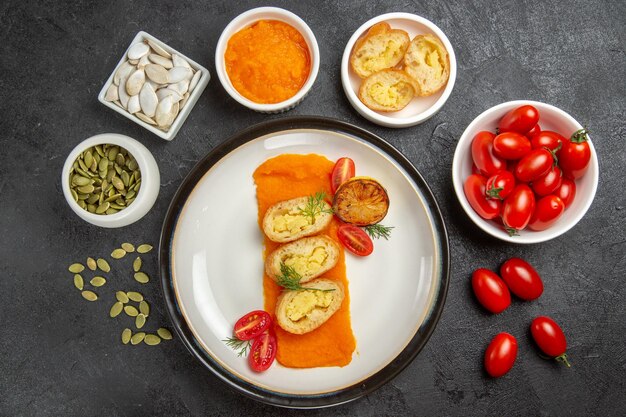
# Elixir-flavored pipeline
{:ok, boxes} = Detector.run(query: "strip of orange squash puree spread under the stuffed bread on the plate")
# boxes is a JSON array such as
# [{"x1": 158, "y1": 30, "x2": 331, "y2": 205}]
[{"x1": 254, "y1": 154, "x2": 356, "y2": 368}]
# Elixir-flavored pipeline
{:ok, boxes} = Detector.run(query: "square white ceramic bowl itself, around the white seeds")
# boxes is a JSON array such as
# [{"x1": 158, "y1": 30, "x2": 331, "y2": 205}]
[{"x1": 98, "y1": 31, "x2": 211, "y2": 140}]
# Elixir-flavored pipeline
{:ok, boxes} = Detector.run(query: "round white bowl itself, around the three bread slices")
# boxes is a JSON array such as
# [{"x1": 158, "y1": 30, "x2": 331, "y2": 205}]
[{"x1": 341, "y1": 13, "x2": 456, "y2": 128}]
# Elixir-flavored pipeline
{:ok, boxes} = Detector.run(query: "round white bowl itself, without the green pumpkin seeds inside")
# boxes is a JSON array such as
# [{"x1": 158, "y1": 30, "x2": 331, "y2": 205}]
[{"x1": 61, "y1": 133, "x2": 161, "y2": 228}]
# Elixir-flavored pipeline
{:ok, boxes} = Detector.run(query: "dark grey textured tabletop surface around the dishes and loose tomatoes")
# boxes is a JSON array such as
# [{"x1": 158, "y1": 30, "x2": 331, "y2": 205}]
[{"x1": 0, "y1": 0, "x2": 626, "y2": 416}]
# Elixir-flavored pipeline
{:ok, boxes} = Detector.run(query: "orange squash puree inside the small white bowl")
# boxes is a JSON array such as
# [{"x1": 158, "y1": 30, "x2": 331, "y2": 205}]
[{"x1": 224, "y1": 20, "x2": 311, "y2": 104}]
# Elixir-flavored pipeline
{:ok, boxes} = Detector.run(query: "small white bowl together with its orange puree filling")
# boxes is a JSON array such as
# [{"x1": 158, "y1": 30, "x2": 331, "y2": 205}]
[{"x1": 215, "y1": 7, "x2": 320, "y2": 113}]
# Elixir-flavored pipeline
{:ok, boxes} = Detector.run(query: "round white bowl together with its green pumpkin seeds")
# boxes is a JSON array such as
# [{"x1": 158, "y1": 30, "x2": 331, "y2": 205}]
[{"x1": 61, "y1": 133, "x2": 160, "y2": 228}]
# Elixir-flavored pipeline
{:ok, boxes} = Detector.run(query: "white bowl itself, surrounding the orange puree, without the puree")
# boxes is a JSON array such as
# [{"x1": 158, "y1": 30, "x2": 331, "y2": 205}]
[{"x1": 215, "y1": 7, "x2": 320, "y2": 113}]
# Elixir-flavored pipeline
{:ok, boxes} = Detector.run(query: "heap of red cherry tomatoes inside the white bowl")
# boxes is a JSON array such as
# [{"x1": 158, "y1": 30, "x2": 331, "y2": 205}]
[{"x1": 464, "y1": 105, "x2": 591, "y2": 236}]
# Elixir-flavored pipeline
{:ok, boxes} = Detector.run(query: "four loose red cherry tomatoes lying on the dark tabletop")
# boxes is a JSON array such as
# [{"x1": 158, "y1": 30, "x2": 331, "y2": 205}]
[{"x1": 472, "y1": 258, "x2": 570, "y2": 378}]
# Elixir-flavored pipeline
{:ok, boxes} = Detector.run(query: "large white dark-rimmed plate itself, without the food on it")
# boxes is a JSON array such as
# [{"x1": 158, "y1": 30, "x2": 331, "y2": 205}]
[{"x1": 160, "y1": 118, "x2": 449, "y2": 407}]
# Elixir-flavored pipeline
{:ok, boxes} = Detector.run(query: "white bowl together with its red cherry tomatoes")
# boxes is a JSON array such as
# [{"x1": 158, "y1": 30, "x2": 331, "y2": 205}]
[{"x1": 452, "y1": 100, "x2": 599, "y2": 243}]
